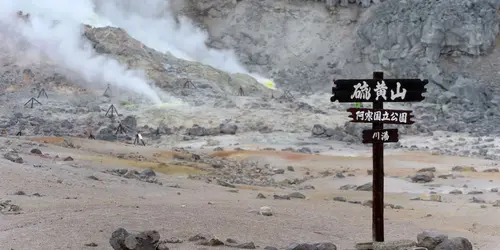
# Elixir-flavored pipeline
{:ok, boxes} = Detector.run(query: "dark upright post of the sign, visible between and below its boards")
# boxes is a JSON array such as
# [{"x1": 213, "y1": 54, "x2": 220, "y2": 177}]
[{"x1": 372, "y1": 72, "x2": 384, "y2": 242}]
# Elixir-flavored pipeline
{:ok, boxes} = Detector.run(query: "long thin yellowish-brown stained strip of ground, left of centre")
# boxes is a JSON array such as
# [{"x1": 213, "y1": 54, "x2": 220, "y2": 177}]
[{"x1": 81, "y1": 156, "x2": 207, "y2": 175}]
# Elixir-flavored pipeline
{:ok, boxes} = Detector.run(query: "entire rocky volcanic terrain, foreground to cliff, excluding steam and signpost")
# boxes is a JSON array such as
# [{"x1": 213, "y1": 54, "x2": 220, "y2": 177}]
[{"x1": 0, "y1": 0, "x2": 500, "y2": 250}]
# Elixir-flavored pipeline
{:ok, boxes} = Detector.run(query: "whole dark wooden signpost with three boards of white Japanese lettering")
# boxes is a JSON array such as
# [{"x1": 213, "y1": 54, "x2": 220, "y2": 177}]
[{"x1": 330, "y1": 72, "x2": 429, "y2": 242}]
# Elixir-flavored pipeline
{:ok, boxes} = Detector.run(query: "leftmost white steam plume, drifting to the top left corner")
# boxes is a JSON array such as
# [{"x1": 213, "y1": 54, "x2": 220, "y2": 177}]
[{"x1": 0, "y1": 0, "x2": 161, "y2": 103}]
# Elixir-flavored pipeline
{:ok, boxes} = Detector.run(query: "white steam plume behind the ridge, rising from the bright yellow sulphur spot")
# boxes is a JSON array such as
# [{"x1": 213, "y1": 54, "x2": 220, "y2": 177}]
[{"x1": 94, "y1": 0, "x2": 276, "y2": 88}]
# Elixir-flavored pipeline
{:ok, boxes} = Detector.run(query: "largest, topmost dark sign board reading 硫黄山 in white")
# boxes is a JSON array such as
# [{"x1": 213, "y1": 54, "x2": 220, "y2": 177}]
[{"x1": 330, "y1": 79, "x2": 429, "y2": 102}]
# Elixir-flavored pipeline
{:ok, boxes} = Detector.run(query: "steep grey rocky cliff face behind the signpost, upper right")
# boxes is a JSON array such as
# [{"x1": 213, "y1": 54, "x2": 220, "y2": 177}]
[{"x1": 173, "y1": 0, "x2": 500, "y2": 134}]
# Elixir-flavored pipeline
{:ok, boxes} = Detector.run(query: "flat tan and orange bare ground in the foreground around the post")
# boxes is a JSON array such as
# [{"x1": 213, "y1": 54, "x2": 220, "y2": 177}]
[{"x1": 0, "y1": 137, "x2": 500, "y2": 250}]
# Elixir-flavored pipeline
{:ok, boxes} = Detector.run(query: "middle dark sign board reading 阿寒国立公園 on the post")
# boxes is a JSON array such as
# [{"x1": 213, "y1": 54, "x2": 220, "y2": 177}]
[{"x1": 347, "y1": 108, "x2": 415, "y2": 124}]
